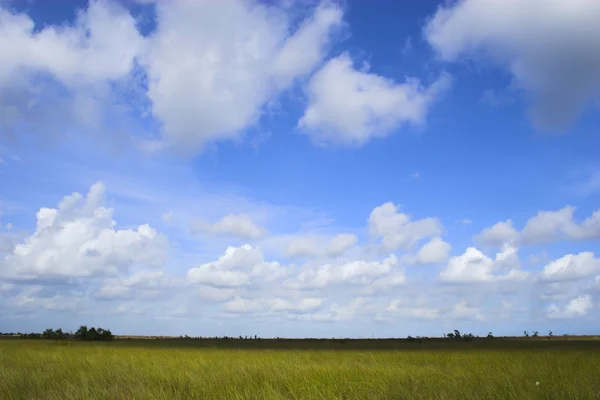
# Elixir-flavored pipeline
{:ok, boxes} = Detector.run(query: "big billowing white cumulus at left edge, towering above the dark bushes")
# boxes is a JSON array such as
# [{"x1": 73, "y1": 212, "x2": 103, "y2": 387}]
[{"x1": 1, "y1": 183, "x2": 168, "y2": 280}]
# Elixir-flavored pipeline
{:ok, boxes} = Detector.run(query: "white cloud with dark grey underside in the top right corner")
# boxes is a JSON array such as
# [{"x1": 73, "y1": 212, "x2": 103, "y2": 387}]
[{"x1": 425, "y1": 0, "x2": 600, "y2": 130}]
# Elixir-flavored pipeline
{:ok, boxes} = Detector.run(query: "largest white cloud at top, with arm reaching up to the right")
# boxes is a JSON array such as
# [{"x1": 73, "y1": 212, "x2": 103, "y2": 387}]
[{"x1": 142, "y1": 0, "x2": 342, "y2": 149}]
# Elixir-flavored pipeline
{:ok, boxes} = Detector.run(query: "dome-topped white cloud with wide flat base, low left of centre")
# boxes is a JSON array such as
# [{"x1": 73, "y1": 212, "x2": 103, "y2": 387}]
[{"x1": 187, "y1": 244, "x2": 291, "y2": 288}]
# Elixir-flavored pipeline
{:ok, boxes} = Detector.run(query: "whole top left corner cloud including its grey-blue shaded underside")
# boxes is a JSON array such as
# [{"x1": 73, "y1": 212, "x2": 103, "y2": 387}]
[{"x1": 0, "y1": 1, "x2": 145, "y2": 133}]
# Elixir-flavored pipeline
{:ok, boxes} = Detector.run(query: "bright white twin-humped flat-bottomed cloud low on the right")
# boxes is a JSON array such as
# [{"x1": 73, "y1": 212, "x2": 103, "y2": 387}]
[{"x1": 439, "y1": 246, "x2": 528, "y2": 282}]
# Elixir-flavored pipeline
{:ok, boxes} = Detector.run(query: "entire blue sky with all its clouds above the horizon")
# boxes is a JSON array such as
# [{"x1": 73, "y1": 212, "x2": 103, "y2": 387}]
[{"x1": 0, "y1": 0, "x2": 600, "y2": 338}]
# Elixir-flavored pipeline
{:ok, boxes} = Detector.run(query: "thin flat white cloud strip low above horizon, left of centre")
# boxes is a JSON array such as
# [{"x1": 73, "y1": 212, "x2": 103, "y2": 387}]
[{"x1": 223, "y1": 296, "x2": 325, "y2": 314}]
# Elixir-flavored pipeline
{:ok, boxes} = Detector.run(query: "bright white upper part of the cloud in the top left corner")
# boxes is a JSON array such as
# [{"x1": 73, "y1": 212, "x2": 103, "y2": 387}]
[{"x1": 0, "y1": 1, "x2": 144, "y2": 86}]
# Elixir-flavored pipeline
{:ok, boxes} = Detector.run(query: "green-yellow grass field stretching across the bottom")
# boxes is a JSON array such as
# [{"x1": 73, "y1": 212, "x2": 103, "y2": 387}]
[{"x1": 0, "y1": 339, "x2": 600, "y2": 400}]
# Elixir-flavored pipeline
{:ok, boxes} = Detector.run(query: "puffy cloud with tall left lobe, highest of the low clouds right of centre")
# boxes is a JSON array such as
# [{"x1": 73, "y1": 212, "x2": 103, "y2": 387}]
[{"x1": 369, "y1": 202, "x2": 442, "y2": 251}]
